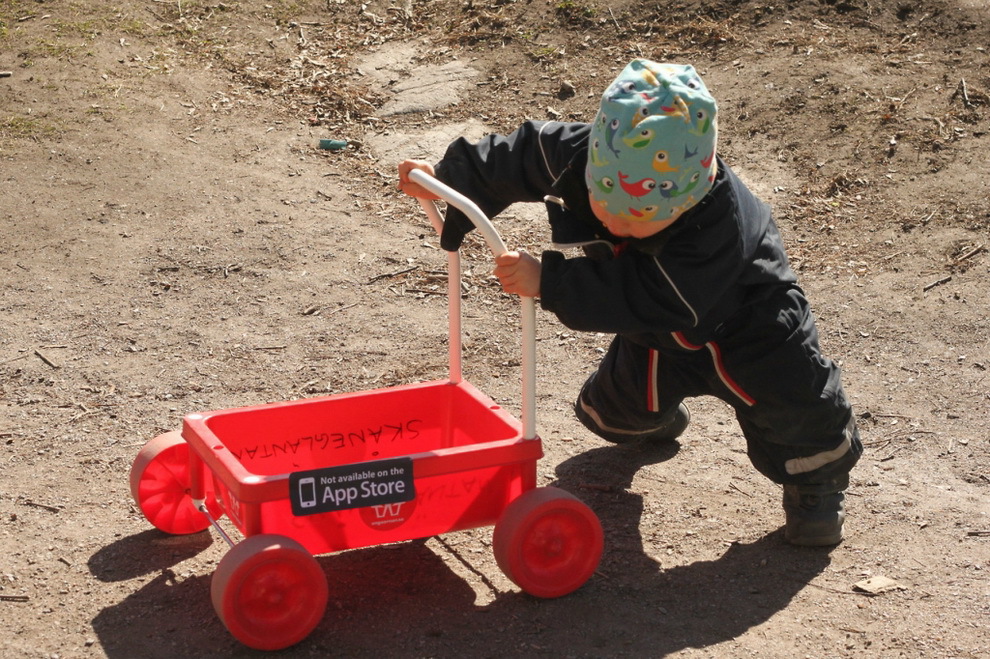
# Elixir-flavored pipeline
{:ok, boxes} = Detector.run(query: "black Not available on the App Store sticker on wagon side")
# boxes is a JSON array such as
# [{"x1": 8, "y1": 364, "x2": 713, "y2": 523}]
[{"x1": 289, "y1": 458, "x2": 416, "y2": 517}]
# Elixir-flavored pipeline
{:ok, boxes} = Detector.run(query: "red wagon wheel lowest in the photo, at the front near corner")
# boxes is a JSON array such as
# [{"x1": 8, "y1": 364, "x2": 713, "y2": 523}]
[{"x1": 210, "y1": 535, "x2": 328, "y2": 650}]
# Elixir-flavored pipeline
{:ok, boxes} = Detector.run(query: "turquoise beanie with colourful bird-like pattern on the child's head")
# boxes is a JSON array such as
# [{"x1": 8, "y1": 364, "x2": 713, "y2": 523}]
[{"x1": 585, "y1": 59, "x2": 718, "y2": 222}]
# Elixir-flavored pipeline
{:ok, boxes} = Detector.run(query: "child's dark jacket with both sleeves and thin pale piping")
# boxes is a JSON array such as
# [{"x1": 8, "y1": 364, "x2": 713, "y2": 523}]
[{"x1": 436, "y1": 122, "x2": 796, "y2": 349}]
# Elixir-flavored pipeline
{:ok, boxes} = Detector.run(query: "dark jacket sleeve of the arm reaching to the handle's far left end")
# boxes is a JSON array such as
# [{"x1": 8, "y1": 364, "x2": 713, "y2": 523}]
[{"x1": 436, "y1": 121, "x2": 588, "y2": 222}]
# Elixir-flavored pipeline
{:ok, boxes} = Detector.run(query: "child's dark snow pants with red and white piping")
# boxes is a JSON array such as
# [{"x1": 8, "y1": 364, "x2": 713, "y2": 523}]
[{"x1": 581, "y1": 287, "x2": 863, "y2": 489}]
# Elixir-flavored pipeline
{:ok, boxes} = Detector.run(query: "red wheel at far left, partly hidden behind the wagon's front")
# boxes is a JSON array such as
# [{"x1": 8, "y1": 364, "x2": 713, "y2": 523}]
[{"x1": 130, "y1": 431, "x2": 221, "y2": 535}]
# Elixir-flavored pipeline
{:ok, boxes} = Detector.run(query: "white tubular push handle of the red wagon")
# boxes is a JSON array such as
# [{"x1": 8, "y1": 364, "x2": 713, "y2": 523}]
[{"x1": 409, "y1": 169, "x2": 536, "y2": 439}]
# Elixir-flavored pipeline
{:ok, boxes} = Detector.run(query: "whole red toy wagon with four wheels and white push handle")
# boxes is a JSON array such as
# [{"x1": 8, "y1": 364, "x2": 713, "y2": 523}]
[{"x1": 130, "y1": 172, "x2": 603, "y2": 650}]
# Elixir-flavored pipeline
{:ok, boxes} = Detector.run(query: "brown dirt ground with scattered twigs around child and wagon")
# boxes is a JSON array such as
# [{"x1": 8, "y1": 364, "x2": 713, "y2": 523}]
[{"x1": 0, "y1": 0, "x2": 990, "y2": 659}]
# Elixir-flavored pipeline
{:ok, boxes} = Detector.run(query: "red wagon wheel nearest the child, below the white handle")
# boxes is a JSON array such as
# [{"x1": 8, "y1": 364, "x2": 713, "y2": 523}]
[{"x1": 492, "y1": 487, "x2": 605, "y2": 598}]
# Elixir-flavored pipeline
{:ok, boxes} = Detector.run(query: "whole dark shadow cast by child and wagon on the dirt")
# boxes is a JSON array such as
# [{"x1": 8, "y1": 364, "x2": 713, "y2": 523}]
[{"x1": 90, "y1": 444, "x2": 830, "y2": 659}]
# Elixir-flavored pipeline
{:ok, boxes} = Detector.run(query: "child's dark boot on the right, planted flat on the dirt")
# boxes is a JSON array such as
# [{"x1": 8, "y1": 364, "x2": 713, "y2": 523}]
[{"x1": 784, "y1": 485, "x2": 846, "y2": 547}]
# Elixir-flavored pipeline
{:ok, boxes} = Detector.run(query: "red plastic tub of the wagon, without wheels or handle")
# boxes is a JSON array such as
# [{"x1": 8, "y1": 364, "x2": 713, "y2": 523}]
[{"x1": 182, "y1": 380, "x2": 543, "y2": 554}]
